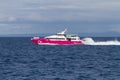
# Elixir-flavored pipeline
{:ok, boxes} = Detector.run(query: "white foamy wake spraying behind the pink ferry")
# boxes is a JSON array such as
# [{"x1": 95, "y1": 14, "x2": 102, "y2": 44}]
[{"x1": 82, "y1": 38, "x2": 120, "y2": 45}]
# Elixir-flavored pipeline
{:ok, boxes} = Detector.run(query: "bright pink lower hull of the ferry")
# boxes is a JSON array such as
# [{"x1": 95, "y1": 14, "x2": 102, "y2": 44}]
[{"x1": 31, "y1": 38, "x2": 83, "y2": 45}]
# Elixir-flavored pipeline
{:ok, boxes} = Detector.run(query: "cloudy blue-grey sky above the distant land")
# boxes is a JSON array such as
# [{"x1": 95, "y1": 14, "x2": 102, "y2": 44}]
[{"x1": 0, "y1": 0, "x2": 120, "y2": 35}]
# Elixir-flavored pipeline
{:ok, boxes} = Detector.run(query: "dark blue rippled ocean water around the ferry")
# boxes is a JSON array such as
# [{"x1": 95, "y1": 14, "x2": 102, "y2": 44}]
[{"x1": 0, "y1": 37, "x2": 120, "y2": 80}]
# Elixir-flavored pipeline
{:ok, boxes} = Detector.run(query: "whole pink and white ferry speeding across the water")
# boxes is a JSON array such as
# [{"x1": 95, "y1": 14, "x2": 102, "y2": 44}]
[{"x1": 31, "y1": 29, "x2": 83, "y2": 45}]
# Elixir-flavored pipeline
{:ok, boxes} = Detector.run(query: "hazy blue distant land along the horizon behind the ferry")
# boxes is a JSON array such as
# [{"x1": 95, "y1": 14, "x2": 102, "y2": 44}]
[{"x1": 0, "y1": 32, "x2": 120, "y2": 37}]
